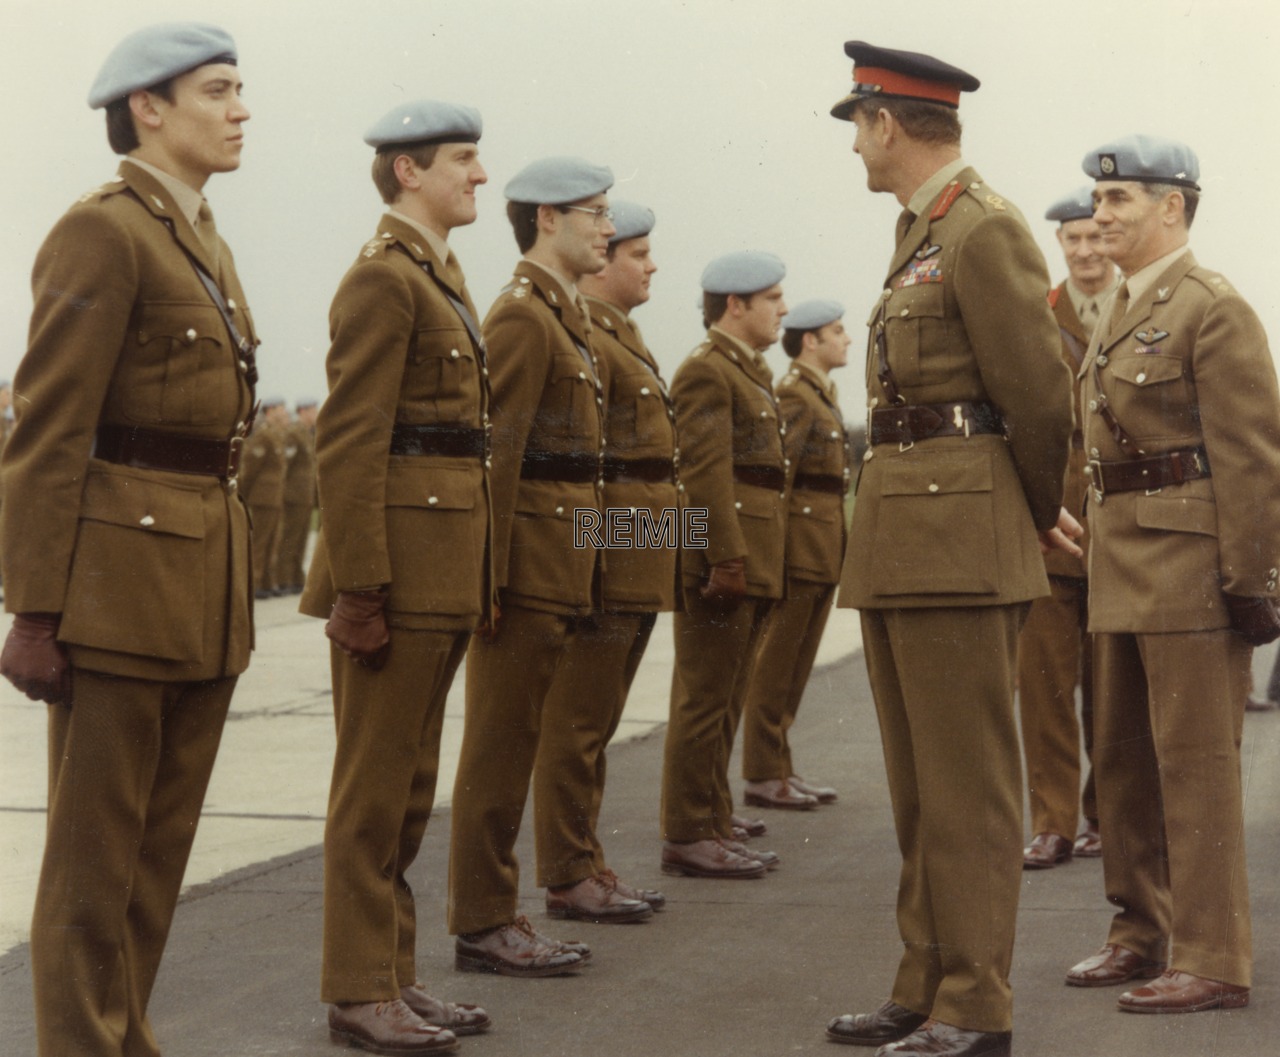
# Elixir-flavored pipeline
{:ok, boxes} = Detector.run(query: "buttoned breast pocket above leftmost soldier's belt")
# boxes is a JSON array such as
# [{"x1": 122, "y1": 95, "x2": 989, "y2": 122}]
[{"x1": 126, "y1": 302, "x2": 239, "y2": 426}]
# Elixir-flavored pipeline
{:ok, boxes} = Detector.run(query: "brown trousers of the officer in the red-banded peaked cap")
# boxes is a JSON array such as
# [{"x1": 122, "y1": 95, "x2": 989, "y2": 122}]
[{"x1": 861, "y1": 604, "x2": 1027, "y2": 1031}]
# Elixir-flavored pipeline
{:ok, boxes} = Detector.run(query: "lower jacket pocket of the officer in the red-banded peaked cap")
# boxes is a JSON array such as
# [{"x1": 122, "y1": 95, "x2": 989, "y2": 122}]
[{"x1": 872, "y1": 452, "x2": 998, "y2": 595}]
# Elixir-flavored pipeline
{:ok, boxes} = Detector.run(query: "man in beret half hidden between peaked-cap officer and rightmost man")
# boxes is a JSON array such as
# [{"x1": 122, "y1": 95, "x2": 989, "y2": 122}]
[{"x1": 1018, "y1": 187, "x2": 1116, "y2": 870}]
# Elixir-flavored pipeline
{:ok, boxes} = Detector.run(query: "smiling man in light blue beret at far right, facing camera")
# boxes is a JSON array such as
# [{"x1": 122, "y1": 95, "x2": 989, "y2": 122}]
[{"x1": 1066, "y1": 136, "x2": 1280, "y2": 1013}]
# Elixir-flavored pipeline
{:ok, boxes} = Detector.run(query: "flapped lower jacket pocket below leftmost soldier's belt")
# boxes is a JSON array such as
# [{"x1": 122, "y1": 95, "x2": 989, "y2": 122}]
[{"x1": 59, "y1": 471, "x2": 205, "y2": 663}]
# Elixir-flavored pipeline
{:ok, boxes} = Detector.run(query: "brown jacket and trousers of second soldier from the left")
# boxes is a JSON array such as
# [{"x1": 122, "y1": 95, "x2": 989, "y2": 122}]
[{"x1": 301, "y1": 215, "x2": 493, "y2": 1002}]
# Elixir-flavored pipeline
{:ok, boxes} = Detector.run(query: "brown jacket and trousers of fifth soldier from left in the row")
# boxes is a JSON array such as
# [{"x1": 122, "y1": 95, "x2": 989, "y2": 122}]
[{"x1": 662, "y1": 328, "x2": 786, "y2": 843}]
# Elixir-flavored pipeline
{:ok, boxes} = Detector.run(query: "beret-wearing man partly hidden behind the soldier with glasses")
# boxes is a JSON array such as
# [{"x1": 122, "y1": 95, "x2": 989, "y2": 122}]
[{"x1": 534, "y1": 202, "x2": 678, "y2": 923}]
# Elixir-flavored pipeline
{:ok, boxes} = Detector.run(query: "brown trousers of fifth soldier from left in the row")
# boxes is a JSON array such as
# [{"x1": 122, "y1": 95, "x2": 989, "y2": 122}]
[{"x1": 662, "y1": 586, "x2": 773, "y2": 843}]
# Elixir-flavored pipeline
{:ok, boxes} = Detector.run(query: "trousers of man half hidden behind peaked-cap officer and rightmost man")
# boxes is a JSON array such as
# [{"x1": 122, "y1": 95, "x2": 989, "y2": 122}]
[{"x1": 1018, "y1": 576, "x2": 1098, "y2": 841}]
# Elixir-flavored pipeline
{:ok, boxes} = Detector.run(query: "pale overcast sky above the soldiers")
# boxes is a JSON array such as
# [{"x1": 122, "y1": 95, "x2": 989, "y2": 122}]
[{"x1": 0, "y1": 0, "x2": 1280, "y2": 421}]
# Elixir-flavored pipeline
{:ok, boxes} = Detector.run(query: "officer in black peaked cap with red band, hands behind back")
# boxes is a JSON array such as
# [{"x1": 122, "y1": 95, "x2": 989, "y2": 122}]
[{"x1": 827, "y1": 41, "x2": 1079, "y2": 1057}]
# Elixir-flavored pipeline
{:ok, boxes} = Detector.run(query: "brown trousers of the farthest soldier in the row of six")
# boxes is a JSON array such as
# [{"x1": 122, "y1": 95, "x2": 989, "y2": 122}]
[{"x1": 742, "y1": 580, "x2": 836, "y2": 782}]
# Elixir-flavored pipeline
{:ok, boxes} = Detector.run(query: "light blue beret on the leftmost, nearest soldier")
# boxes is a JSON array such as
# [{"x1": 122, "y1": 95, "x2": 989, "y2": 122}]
[{"x1": 88, "y1": 22, "x2": 236, "y2": 110}]
